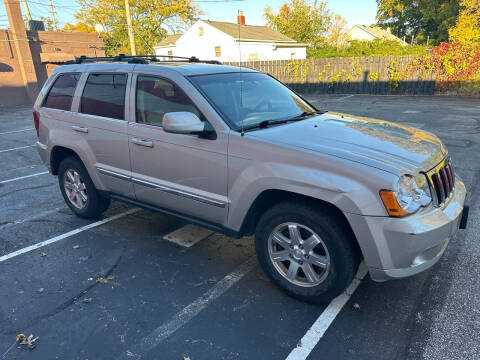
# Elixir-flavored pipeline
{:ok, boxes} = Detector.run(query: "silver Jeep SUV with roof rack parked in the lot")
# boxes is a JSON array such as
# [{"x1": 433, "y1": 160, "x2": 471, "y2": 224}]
[{"x1": 34, "y1": 57, "x2": 468, "y2": 302}]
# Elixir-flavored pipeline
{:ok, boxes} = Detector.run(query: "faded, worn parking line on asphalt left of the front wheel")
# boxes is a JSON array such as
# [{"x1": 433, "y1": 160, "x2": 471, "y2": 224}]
[{"x1": 123, "y1": 258, "x2": 257, "y2": 358}]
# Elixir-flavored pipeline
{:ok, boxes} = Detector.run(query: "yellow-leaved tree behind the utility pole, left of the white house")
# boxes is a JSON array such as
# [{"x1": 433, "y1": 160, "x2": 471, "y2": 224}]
[{"x1": 75, "y1": 0, "x2": 200, "y2": 55}]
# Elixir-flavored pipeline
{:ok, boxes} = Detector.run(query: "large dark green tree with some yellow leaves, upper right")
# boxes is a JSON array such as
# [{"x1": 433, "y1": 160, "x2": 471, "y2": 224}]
[{"x1": 377, "y1": 0, "x2": 460, "y2": 44}]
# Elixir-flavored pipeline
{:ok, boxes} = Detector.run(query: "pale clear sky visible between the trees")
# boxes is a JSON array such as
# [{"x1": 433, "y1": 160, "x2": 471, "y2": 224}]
[{"x1": 0, "y1": 0, "x2": 377, "y2": 28}]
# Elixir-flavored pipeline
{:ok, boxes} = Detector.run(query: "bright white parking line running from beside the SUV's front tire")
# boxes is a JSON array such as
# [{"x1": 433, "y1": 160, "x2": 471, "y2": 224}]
[{"x1": 286, "y1": 262, "x2": 367, "y2": 360}]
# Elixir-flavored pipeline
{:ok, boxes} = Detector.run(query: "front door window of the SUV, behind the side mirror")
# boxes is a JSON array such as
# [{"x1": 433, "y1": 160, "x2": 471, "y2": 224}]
[{"x1": 136, "y1": 75, "x2": 204, "y2": 126}]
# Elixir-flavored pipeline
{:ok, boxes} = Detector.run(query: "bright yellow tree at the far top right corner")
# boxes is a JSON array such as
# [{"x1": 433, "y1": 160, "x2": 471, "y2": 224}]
[{"x1": 450, "y1": 0, "x2": 480, "y2": 45}]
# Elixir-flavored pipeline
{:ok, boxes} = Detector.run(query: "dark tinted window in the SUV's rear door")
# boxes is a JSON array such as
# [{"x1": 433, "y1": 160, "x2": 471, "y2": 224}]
[{"x1": 80, "y1": 74, "x2": 127, "y2": 120}]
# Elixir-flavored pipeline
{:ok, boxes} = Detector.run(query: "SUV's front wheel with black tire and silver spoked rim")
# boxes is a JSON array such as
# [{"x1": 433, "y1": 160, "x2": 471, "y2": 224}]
[{"x1": 255, "y1": 200, "x2": 360, "y2": 303}]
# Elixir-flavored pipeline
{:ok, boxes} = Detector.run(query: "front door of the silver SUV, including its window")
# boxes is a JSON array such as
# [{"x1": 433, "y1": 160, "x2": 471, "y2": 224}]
[{"x1": 128, "y1": 74, "x2": 228, "y2": 224}]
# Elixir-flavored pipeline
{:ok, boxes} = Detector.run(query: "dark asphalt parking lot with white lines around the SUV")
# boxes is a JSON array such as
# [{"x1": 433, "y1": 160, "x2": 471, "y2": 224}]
[{"x1": 0, "y1": 95, "x2": 480, "y2": 360}]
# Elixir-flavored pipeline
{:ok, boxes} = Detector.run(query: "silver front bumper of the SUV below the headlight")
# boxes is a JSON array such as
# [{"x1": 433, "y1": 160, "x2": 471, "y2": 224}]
[{"x1": 346, "y1": 177, "x2": 468, "y2": 281}]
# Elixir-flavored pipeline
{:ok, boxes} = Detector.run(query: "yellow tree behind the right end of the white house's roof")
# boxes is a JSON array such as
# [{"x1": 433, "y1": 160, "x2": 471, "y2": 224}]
[{"x1": 264, "y1": 0, "x2": 331, "y2": 46}]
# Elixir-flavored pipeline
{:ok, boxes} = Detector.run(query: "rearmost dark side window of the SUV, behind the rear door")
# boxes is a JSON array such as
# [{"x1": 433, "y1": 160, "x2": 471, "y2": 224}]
[{"x1": 43, "y1": 73, "x2": 80, "y2": 111}]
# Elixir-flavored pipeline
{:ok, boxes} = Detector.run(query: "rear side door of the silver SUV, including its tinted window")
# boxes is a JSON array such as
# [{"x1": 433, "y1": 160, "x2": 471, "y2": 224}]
[{"x1": 66, "y1": 66, "x2": 134, "y2": 197}]
